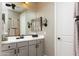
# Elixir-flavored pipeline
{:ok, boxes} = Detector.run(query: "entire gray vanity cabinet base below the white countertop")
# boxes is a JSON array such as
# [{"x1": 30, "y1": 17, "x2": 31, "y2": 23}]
[{"x1": 1, "y1": 39, "x2": 44, "y2": 56}]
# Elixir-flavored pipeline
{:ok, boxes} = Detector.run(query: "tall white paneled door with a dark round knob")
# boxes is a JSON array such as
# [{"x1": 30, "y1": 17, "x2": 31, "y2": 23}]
[{"x1": 55, "y1": 2, "x2": 74, "y2": 56}]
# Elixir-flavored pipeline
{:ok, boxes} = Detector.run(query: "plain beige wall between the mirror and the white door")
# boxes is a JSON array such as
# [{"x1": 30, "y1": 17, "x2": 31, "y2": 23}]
[{"x1": 37, "y1": 2, "x2": 54, "y2": 56}]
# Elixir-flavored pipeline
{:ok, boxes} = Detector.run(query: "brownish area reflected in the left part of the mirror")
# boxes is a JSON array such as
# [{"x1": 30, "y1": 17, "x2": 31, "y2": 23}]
[{"x1": 8, "y1": 10, "x2": 20, "y2": 36}]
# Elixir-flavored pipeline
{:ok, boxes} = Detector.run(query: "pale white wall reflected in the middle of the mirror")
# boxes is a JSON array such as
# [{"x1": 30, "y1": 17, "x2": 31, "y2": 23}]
[{"x1": 20, "y1": 10, "x2": 36, "y2": 35}]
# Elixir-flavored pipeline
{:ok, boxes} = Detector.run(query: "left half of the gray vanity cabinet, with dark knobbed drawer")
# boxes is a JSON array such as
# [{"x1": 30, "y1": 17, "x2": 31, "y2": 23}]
[{"x1": 2, "y1": 41, "x2": 28, "y2": 56}]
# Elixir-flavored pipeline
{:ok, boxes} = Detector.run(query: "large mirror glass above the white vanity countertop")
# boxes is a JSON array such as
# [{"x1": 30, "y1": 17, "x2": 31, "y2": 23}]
[{"x1": 2, "y1": 2, "x2": 41, "y2": 36}]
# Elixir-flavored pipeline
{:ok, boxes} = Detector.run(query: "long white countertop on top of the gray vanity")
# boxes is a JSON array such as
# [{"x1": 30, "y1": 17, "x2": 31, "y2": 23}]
[{"x1": 1, "y1": 35, "x2": 44, "y2": 44}]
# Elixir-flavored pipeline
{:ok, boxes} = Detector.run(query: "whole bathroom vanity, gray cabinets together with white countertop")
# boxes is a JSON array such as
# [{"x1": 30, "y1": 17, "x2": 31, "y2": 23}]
[{"x1": 1, "y1": 35, "x2": 44, "y2": 56}]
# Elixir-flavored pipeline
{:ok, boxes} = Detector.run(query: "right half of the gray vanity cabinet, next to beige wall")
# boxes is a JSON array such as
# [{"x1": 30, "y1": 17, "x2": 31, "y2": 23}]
[{"x1": 29, "y1": 39, "x2": 44, "y2": 56}]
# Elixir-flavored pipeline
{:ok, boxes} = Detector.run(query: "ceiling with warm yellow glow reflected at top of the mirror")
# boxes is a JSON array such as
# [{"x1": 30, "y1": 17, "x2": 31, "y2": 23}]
[{"x1": 3, "y1": 2, "x2": 36, "y2": 13}]
